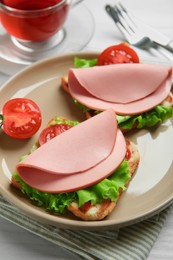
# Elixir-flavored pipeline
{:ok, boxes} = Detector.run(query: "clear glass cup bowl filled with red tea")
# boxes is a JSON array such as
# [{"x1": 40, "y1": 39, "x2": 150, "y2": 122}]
[{"x1": 0, "y1": 0, "x2": 70, "y2": 42}]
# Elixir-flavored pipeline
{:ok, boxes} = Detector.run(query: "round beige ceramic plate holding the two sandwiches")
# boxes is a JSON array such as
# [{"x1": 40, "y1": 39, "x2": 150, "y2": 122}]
[{"x1": 0, "y1": 53, "x2": 173, "y2": 230}]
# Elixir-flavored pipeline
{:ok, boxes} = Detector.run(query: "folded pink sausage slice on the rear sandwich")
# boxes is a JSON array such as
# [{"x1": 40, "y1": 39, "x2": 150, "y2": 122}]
[{"x1": 68, "y1": 64, "x2": 172, "y2": 115}]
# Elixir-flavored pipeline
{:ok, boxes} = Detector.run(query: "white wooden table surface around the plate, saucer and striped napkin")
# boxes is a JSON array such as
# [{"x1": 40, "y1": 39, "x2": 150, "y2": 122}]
[{"x1": 0, "y1": 0, "x2": 173, "y2": 260}]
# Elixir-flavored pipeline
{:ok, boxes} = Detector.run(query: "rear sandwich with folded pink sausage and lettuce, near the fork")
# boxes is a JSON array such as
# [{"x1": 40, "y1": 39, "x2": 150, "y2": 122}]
[{"x1": 61, "y1": 58, "x2": 173, "y2": 132}]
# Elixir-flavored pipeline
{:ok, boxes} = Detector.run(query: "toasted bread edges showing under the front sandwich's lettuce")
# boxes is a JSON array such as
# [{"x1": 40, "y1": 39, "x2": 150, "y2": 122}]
[{"x1": 68, "y1": 140, "x2": 140, "y2": 221}]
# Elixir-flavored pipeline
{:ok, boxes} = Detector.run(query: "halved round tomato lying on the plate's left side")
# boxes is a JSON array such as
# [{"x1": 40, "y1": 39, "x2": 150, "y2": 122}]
[{"x1": 2, "y1": 98, "x2": 42, "y2": 139}]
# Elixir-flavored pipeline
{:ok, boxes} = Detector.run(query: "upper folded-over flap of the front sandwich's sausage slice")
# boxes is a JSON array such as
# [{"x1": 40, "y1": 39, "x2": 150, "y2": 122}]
[{"x1": 17, "y1": 110, "x2": 117, "y2": 174}]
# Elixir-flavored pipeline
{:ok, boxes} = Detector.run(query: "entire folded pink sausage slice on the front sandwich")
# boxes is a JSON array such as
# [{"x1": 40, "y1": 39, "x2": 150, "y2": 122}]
[{"x1": 17, "y1": 110, "x2": 126, "y2": 192}]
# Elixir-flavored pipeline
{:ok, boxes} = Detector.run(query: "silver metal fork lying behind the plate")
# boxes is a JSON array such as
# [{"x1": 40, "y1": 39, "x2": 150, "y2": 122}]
[{"x1": 105, "y1": 3, "x2": 173, "y2": 60}]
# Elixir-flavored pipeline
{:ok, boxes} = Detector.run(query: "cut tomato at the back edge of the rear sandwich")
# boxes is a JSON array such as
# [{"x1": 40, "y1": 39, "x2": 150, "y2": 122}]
[{"x1": 97, "y1": 43, "x2": 139, "y2": 66}]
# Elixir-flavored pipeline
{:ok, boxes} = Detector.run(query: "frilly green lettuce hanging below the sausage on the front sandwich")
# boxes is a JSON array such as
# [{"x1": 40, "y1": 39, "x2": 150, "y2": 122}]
[{"x1": 13, "y1": 160, "x2": 131, "y2": 214}]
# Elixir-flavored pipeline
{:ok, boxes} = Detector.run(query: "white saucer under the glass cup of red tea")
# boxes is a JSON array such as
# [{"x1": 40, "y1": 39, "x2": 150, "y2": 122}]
[{"x1": 0, "y1": 4, "x2": 94, "y2": 65}]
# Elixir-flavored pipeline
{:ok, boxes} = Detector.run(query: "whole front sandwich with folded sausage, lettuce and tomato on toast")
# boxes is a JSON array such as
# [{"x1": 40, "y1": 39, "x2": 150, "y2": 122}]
[{"x1": 11, "y1": 109, "x2": 140, "y2": 221}]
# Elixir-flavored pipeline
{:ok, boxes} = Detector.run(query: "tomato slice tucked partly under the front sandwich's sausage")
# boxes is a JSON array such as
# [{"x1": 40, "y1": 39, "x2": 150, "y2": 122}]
[{"x1": 38, "y1": 124, "x2": 72, "y2": 145}]
